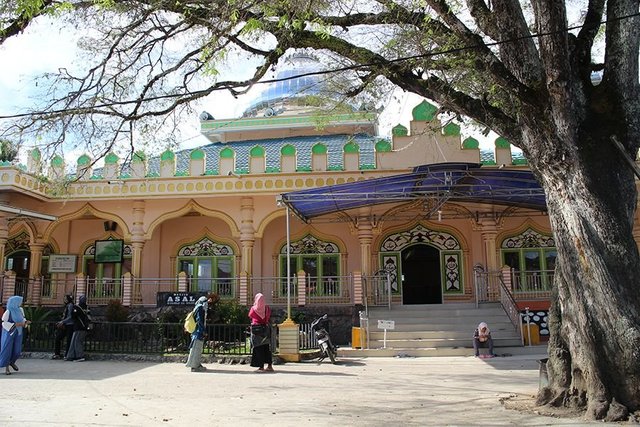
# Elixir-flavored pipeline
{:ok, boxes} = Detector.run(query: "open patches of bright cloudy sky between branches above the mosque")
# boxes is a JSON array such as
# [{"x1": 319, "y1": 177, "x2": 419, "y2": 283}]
[{"x1": 0, "y1": 17, "x2": 496, "y2": 164}]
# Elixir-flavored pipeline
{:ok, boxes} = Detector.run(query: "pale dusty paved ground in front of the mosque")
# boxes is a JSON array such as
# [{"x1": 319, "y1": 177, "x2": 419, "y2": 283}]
[{"x1": 0, "y1": 356, "x2": 602, "y2": 427}]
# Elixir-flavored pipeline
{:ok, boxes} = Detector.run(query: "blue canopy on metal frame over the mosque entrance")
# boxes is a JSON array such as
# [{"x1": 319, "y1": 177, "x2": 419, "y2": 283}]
[{"x1": 281, "y1": 163, "x2": 547, "y2": 222}]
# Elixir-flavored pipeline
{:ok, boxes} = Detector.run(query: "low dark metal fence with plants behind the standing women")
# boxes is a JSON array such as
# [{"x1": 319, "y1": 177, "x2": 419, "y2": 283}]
[{"x1": 23, "y1": 322, "x2": 258, "y2": 356}]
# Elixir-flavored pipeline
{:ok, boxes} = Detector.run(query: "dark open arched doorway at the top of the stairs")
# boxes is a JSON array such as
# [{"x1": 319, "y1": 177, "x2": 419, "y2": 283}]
[{"x1": 401, "y1": 244, "x2": 442, "y2": 304}]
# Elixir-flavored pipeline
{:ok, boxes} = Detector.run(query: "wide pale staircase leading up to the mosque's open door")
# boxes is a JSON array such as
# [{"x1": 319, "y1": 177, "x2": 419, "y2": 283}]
[{"x1": 338, "y1": 303, "x2": 546, "y2": 357}]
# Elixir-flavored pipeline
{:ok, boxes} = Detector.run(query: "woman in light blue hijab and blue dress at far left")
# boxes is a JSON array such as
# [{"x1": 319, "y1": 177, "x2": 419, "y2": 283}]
[{"x1": 0, "y1": 295, "x2": 30, "y2": 375}]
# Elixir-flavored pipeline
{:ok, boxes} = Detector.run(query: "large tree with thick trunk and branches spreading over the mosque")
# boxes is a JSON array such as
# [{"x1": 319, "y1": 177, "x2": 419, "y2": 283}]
[{"x1": 0, "y1": 0, "x2": 640, "y2": 420}]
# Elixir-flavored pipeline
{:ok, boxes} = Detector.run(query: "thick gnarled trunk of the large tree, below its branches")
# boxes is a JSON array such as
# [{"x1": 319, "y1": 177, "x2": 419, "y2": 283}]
[{"x1": 532, "y1": 131, "x2": 640, "y2": 421}]
